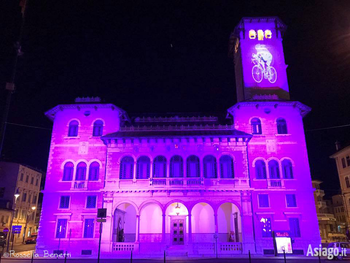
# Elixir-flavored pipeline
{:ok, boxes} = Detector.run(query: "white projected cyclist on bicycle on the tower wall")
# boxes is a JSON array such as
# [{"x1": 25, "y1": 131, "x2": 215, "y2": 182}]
[{"x1": 252, "y1": 44, "x2": 277, "y2": 83}]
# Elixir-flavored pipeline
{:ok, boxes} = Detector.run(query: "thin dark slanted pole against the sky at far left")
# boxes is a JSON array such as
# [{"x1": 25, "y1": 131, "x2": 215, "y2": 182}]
[{"x1": 0, "y1": 0, "x2": 28, "y2": 159}]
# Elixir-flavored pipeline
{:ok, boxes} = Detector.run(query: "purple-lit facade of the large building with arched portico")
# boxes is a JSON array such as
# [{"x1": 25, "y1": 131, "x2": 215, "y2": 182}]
[{"x1": 37, "y1": 18, "x2": 320, "y2": 257}]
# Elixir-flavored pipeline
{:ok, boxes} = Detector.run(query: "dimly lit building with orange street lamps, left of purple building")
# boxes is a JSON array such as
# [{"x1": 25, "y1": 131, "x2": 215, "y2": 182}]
[{"x1": 0, "y1": 162, "x2": 42, "y2": 243}]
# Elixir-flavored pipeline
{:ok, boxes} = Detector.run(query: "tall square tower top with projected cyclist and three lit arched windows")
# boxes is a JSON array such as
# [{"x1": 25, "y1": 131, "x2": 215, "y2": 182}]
[{"x1": 230, "y1": 17, "x2": 289, "y2": 102}]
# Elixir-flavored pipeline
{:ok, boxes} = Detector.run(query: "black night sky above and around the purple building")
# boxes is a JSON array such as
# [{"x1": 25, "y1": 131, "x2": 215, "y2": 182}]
[{"x1": 0, "y1": 0, "x2": 350, "y2": 198}]
